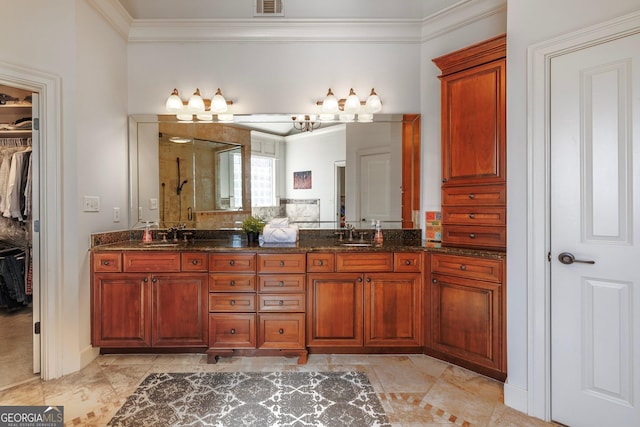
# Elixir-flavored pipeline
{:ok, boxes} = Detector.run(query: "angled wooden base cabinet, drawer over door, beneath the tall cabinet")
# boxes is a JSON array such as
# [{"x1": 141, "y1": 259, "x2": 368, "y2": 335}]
[{"x1": 425, "y1": 254, "x2": 507, "y2": 381}]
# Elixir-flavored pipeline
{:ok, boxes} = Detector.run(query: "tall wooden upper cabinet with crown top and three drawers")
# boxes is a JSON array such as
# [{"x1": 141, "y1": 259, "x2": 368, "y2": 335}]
[{"x1": 433, "y1": 35, "x2": 506, "y2": 249}]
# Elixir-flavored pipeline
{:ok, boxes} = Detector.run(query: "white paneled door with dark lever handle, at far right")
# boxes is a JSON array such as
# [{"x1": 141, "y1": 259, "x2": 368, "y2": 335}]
[{"x1": 550, "y1": 34, "x2": 640, "y2": 427}]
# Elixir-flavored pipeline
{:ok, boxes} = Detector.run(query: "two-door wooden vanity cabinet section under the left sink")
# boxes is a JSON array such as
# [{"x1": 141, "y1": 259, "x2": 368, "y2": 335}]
[{"x1": 92, "y1": 251, "x2": 208, "y2": 348}]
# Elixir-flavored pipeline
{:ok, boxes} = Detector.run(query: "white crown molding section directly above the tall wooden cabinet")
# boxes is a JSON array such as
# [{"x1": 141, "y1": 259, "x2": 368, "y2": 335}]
[{"x1": 421, "y1": 0, "x2": 507, "y2": 43}]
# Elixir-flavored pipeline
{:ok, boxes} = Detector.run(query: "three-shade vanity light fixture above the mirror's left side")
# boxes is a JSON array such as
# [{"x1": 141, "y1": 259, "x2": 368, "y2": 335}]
[{"x1": 165, "y1": 88, "x2": 233, "y2": 122}]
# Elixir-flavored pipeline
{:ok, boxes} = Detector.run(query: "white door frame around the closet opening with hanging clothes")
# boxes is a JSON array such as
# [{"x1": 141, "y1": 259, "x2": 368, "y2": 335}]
[{"x1": 0, "y1": 61, "x2": 63, "y2": 380}]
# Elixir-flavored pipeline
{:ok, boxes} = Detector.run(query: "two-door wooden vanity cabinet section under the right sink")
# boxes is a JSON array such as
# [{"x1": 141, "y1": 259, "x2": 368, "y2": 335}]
[{"x1": 307, "y1": 252, "x2": 422, "y2": 350}]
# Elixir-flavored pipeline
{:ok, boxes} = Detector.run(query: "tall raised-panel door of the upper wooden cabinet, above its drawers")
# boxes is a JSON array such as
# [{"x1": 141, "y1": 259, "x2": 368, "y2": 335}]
[{"x1": 441, "y1": 59, "x2": 506, "y2": 184}]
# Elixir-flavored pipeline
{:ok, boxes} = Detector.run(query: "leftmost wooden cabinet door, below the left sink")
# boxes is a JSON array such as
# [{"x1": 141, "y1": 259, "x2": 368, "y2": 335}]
[{"x1": 91, "y1": 273, "x2": 151, "y2": 347}]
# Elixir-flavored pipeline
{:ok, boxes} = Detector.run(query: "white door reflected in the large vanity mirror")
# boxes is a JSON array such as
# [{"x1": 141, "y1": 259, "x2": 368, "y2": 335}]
[{"x1": 359, "y1": 152, "x2": 391, "y2": 222}]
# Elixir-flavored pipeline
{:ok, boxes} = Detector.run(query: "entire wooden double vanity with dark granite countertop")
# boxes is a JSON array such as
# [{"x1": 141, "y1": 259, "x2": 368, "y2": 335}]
[{"x1": 91, "y1": 229, "x2": 506, "y2": 380}]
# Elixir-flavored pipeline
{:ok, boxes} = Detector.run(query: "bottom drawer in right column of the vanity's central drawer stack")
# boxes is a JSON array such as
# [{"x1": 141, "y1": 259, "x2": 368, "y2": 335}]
[{"x1": 258, "y1": 313, "x2": 305, "y2": 349}]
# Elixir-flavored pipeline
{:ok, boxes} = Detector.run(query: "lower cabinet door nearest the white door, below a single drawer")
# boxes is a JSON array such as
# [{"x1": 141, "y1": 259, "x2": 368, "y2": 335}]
[{"x1": 430, "y1": 274, "x2": 505, "y2": 371}]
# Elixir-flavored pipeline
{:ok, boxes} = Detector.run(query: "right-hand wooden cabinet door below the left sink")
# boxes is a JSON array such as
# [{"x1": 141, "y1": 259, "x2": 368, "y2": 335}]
[{"x1": 151, "y1": 273, "x2": 208, "y2": 347}]
